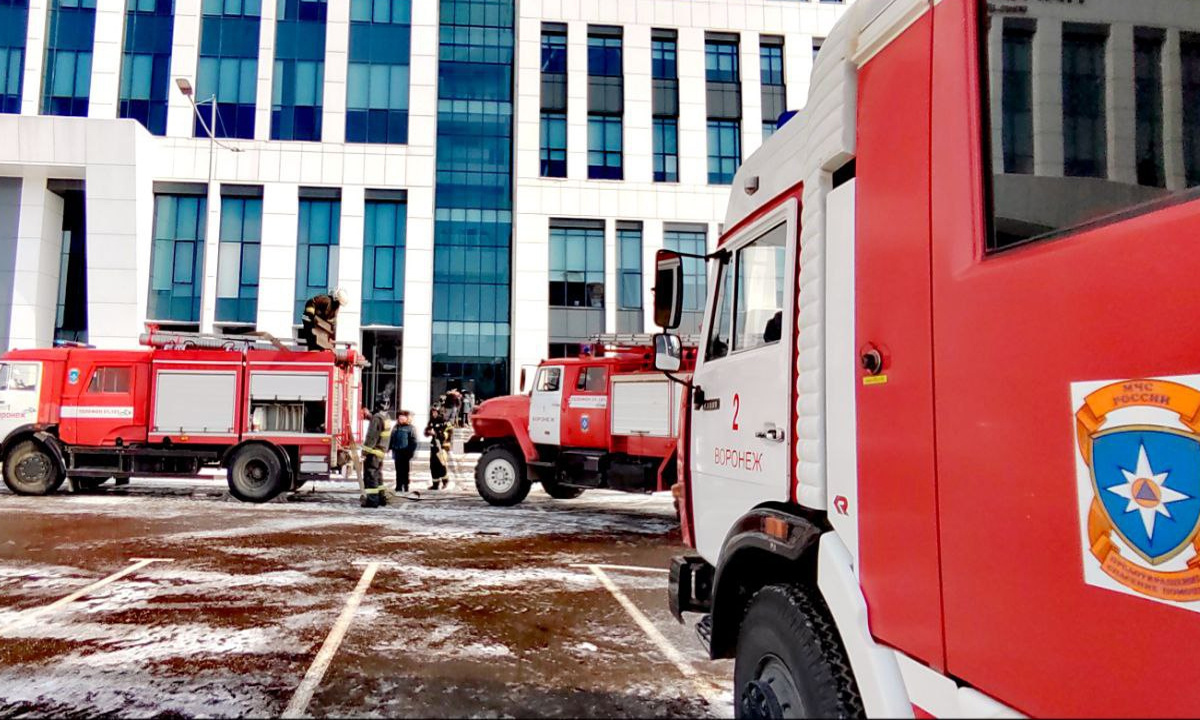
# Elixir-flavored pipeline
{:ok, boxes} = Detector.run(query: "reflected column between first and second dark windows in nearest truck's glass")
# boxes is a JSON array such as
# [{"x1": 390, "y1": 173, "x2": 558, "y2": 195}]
[{"x1": 1033, "y1": 18, "x2": 1064, "y2": 178}]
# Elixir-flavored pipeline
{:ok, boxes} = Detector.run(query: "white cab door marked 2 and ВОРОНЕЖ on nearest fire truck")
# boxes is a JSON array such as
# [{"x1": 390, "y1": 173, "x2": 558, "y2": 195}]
[{"x1": 691, "y1": 207, "x2": 798, "y2": 557}]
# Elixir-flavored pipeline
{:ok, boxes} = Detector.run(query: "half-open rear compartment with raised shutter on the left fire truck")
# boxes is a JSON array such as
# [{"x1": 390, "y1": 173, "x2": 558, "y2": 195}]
[{"x1": 250, "y1": 371, "x2": 329, "y2": 434}]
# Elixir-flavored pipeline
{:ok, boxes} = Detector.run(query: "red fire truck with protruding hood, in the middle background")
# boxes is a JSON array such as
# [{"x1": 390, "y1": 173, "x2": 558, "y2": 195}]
[{"x1": 466, "y1": 335, "x2": 695, "y2": 505}]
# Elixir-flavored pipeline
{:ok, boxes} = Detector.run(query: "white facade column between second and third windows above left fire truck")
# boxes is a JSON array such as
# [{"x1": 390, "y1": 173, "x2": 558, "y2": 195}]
[{"x1": 258, "y1": 184, "x2": 300, "y2": 337}]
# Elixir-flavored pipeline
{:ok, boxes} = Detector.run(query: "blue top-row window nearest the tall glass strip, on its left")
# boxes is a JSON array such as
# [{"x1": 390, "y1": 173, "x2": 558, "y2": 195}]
[{"x1": 346, "y1": 0, "x2": 412, "y2": 144}]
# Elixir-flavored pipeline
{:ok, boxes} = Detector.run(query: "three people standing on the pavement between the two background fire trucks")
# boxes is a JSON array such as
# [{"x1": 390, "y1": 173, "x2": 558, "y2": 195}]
[{"x1": 355, "y1": 396, "x2": 454, "y2": 508}]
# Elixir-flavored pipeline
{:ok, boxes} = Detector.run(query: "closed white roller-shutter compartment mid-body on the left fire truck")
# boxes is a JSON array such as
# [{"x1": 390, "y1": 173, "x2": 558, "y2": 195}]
[{"x1": 151, "y1": 370, "x2": 238, "y2": 434}]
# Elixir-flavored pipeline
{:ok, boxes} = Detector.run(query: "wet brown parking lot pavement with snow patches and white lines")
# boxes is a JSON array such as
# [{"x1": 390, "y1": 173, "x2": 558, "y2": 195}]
[{"x1": 0, "y1": 458, "x2": 732, "y2": 718}]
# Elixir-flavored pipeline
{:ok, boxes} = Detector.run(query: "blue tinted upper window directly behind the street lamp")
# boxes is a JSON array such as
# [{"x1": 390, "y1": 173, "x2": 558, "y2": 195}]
[{"x1": 196, "y1": 0, "x2": 262, "y2": 139}]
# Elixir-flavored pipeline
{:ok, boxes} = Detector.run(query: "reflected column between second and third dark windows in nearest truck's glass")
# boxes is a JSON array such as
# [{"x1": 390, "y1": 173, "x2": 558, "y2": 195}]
[{"x1": 1104, "y1": 24, "x2": 1138, "y2": 185}]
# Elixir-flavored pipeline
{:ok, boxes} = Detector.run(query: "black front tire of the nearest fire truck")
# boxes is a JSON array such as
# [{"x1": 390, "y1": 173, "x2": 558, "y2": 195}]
[{"x1": 733, "y1": 584, "x2": 865, "y2": 718}]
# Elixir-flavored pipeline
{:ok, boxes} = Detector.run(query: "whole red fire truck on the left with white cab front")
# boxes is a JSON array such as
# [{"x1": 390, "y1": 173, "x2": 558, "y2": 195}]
[{"x1": 0, "y1": 328, "x2": 365, "y2": 503}]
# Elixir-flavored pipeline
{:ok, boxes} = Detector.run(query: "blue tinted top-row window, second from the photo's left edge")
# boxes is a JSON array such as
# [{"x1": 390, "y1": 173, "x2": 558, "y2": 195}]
[{"x1": 42, "y1": 0, "x2": 96, "y2": 118}]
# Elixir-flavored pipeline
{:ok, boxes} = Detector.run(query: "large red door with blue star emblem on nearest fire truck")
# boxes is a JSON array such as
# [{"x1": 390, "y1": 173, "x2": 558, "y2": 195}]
[{"x1": 926, "y1": 0, "x2": 1200, "y2": 716}]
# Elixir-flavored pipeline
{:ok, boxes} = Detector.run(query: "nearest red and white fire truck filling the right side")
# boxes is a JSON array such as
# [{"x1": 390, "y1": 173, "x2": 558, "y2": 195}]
[{"x1": 656, "y1": 0, "x2": 1200, "y2": 716}]
